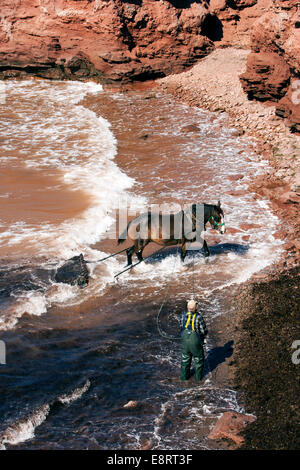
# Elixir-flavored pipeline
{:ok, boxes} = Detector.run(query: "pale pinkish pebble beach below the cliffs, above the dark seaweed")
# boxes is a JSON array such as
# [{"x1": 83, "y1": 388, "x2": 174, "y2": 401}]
[{"x1": 157, "y1": 48, "x2": 300, "y2": 266}]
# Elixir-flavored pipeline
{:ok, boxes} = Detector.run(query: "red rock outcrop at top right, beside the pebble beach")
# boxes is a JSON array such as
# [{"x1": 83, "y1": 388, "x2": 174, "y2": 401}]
[{"x1": 241, "y1": 0, "x2": 300, "y2": 132}]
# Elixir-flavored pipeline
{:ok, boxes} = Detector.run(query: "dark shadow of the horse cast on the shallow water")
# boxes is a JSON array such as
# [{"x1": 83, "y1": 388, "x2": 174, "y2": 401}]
[{"x1": 145, "y1": 243, "x2": 249, "y2": 264}]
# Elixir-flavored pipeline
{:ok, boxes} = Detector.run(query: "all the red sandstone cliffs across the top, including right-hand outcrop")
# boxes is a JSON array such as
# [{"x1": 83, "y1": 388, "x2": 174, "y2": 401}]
[{"x1": 0, "y1": 0, "x2": 300, "y2": 132}]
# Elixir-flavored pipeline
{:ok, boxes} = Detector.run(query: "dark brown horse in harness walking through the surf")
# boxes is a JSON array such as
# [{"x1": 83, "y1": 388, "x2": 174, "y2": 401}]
[{"x1": 118, "y1": 201, "x2": 226, "y2": 266}]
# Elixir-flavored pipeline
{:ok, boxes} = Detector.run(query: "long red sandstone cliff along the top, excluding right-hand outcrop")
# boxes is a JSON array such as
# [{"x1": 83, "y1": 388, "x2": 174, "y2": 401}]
[{"x1": 0, "y1": 0, "x2": 269, "y2": 81}]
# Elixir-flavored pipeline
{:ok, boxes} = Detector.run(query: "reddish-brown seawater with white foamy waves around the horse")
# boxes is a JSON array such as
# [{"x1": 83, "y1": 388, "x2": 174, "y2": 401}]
[{"x1": 0, "y1": 80, "x2": 281, "y2": 449}]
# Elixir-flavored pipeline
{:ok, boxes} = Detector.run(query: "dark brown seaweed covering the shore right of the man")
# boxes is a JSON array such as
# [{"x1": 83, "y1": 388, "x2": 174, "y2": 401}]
[{"x1": 234, "y1": 267, "x2": 300, "y2": 450}]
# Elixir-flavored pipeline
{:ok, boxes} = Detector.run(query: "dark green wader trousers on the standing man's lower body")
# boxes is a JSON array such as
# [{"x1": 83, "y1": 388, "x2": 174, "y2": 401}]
[{"x1": 180, "y1": 329, "x2": 204, "y2": 382}]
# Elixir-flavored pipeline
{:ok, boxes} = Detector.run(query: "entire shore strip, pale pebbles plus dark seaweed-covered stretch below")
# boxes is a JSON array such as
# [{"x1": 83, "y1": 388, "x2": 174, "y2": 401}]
[{"x1": 157, "y1": 48, "x2": 300, "y2": 449}]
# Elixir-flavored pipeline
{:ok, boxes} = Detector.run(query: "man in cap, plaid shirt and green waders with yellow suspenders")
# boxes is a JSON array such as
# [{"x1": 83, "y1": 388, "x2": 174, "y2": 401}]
[{"x1": 180, "y1": 300, "x2": 207, "y2": 382}]
